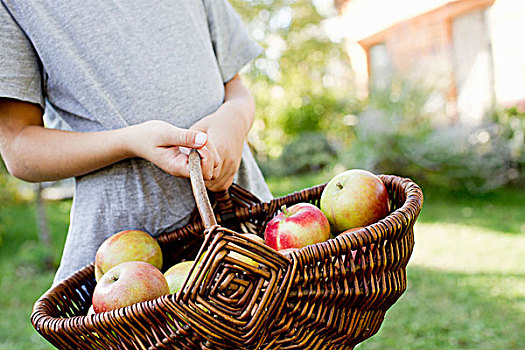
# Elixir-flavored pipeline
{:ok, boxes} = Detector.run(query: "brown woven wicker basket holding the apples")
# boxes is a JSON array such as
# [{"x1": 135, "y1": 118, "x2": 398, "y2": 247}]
[{"x1": 31, "y1": 150, "x2": 423, "y2": 349}]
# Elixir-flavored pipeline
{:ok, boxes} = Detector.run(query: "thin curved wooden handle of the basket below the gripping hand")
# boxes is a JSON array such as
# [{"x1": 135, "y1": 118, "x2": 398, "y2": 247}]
[{"x1": 189, "y1": 149, "x2": 217, "y2": 229}]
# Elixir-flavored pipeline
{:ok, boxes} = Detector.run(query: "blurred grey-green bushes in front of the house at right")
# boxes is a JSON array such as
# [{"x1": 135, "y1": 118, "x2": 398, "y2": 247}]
[{"x1": 341, "y1": 85, "x2": 523, "y2": 193}]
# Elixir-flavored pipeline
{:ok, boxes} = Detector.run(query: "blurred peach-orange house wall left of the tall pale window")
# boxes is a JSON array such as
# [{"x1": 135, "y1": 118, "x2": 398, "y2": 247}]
[{"x1": 360, "y1": 3, "x2": 457, "y2": 123}]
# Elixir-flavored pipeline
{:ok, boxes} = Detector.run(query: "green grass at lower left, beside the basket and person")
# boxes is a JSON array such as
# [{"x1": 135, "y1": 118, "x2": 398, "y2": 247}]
[{"x1": 0, "y1": 202, "x2": 70, "y2": 350}]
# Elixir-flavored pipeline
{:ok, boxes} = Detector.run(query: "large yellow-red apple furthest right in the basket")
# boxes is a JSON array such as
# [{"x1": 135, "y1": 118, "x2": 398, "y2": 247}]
[{"x1": 320, "y1": 169, "x2": 389, "y2": 232}]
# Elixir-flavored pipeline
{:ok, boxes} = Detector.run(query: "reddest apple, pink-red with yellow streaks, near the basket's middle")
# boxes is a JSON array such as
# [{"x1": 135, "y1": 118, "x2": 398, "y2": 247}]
[{"x1": 264, "y1": 203, "x2": 330, "y2": 250}]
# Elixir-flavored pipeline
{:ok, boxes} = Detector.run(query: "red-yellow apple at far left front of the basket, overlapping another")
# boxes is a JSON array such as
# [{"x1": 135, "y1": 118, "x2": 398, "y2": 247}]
[{"x1": 93, "y1": 261, "x2": 170, "y2": 313}]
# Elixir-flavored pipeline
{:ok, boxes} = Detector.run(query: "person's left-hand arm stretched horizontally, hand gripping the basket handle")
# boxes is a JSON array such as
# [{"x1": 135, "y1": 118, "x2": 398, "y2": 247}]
[{"x1": 0, "y1": 99, "x2": 214, "y2": 182}]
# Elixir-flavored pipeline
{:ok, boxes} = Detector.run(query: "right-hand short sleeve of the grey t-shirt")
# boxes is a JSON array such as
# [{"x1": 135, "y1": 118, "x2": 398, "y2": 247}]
[{"x1": 204, "y1": 0, "x2": 262, "y2": 83}]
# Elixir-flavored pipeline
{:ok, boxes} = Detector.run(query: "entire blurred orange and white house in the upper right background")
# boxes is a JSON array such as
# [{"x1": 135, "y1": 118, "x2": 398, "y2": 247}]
[{"x1": 344, "y1": 0, "x2": 500, "y2": 124}]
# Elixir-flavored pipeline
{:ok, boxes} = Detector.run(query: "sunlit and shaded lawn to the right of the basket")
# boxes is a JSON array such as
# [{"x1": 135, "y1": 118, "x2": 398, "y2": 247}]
[{"x1": 358, "y1": 224, "x2": 525, "y2": 350}]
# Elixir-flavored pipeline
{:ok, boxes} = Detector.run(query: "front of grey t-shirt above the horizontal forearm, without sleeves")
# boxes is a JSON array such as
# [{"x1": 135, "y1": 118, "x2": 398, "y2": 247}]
[{"x1": 4, "y1": 0, "x2": 224, "y2": 131}]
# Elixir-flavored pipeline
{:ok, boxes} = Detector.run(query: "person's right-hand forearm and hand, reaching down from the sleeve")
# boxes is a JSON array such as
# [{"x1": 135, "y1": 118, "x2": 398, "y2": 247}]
[{"x1": 191, "y1": 75, "x2": 255, "y2": 191}]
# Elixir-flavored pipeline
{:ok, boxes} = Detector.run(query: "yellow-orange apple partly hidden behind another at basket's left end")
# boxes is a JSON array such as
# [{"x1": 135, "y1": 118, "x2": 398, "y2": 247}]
[{"x1": 95, "y1": 230, "x2": 162, "y2": 282}]
